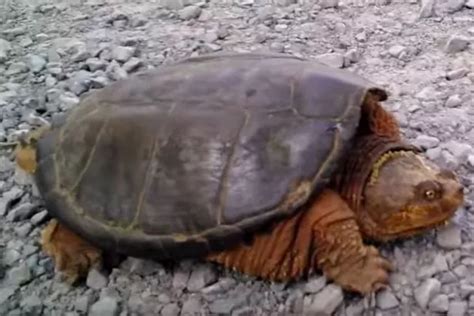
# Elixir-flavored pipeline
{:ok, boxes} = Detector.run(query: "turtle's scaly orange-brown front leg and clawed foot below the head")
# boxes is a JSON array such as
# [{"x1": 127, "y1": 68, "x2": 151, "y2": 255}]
[{"x1": 310, "y1": 191, "x2": 393, "y2": 294}]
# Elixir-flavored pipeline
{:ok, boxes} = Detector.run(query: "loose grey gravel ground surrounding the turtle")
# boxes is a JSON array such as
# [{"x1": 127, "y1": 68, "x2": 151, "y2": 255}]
[{"x1": 0, "y1": 0, "x2": 474, "y2": 316}]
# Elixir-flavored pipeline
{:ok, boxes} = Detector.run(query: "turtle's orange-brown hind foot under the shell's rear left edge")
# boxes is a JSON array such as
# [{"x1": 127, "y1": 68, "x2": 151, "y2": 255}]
[{"x1": 41, "y1": 219, "x2": 102, "y2": 285}]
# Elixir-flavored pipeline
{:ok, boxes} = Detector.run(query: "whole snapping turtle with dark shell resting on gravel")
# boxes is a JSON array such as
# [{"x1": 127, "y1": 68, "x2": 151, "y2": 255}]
[{"x1": 16, "y1": 52, "x2": 464, "y2": 294}]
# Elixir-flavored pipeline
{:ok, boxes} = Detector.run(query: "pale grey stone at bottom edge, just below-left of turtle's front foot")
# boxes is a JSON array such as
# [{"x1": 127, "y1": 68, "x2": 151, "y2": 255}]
[{"x1": 303, "y1": 283, "x2": 344, "y2": 315}]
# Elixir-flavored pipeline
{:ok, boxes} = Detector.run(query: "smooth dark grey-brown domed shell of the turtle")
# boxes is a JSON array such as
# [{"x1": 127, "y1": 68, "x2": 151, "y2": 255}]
[{"x1": 35, "y1": 53, "x2": 386, "y2": 259}]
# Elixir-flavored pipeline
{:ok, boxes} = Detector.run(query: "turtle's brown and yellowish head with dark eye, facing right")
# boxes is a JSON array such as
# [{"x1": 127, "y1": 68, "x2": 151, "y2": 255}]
[{"x1": 359, "y1": 151, "x2": 464, "y2": 240}]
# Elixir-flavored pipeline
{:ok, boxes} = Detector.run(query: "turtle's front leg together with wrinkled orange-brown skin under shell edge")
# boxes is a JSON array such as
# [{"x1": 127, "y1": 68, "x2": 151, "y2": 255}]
[{"x1": 206, "y1": 190, "x2": 392, "y2": 295}]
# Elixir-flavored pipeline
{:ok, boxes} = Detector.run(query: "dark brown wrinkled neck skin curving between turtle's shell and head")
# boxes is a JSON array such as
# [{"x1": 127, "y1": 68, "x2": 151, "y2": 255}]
[{"x1": 333, "y1": 135, "x2": 419, "y2": 241}]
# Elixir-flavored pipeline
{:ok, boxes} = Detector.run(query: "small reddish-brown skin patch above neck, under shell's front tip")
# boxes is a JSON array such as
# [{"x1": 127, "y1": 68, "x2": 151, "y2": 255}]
[{"x1": 360, "y1": 92, "x2": 401, "y2": 140}]
